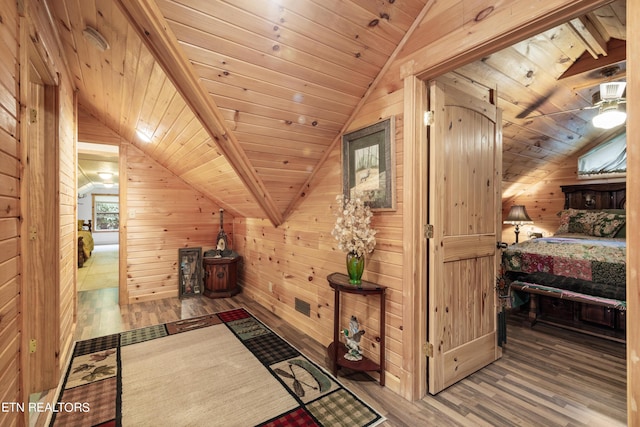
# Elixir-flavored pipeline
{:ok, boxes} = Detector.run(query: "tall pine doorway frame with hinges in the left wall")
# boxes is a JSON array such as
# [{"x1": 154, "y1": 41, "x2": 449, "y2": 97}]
[{"x1": 19, "y1": 25, "x2": 60, "y2": 394}]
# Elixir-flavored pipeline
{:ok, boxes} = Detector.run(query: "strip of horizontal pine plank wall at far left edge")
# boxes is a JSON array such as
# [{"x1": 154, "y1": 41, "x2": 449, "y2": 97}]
[{"x1": 0, "y1": 0, "x2": 24, "y2": 425}]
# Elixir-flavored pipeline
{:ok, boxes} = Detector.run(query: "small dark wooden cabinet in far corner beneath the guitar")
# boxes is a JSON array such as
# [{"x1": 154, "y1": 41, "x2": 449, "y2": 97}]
[{"x1": 202, "y1": 256, "x2": 242, "y2": 298}]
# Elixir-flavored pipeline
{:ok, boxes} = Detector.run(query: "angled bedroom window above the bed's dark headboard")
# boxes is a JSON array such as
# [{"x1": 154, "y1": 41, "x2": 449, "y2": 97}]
[{"x1": 578, "y1": 133, "x2": 627, "y2": 179}]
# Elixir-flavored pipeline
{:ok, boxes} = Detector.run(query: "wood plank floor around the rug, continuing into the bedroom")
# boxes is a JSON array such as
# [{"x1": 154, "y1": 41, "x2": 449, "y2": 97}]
[{"x1": 70, "y1": 288, "x2": 626, "y2": 427}]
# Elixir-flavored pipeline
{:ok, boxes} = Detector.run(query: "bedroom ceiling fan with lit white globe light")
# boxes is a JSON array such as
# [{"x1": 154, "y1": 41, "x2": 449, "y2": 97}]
[{"x1": 527, "y1": 82, "x2": 627, "y2": 129}]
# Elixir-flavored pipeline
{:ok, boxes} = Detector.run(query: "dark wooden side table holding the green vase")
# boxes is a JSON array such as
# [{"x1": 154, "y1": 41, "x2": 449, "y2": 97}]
[{"x1": 327, "y1": 273, "x2": 387, "y2": 386}]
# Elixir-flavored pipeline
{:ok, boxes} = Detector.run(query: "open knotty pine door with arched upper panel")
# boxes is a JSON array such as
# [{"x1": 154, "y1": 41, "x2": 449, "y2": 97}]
[{"x1": 427, "y1": 77, "x2": 502, "y2": 394}]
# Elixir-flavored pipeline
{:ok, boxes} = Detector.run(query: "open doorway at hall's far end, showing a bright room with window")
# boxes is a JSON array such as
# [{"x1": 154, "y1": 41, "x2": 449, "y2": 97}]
[{"x1": 77, "y1": 142, "x2": 120, "y2": 292}]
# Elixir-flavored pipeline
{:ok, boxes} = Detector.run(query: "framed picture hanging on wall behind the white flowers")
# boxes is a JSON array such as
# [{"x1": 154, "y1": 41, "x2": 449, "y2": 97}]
[{"x1": 342, "y1": 116, "x2": 396, "y2": 211}]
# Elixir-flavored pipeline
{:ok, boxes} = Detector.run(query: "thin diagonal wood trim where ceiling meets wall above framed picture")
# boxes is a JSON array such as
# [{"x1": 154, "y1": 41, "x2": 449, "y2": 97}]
[{"x1": 284, "y1": 0, "x2": 436, "y2": 218}]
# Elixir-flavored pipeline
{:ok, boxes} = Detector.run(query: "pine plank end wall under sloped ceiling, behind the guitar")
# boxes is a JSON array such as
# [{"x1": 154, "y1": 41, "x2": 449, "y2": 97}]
[{"x1": 122, "y1": 146, "x2": 234, "y2": 303}]
